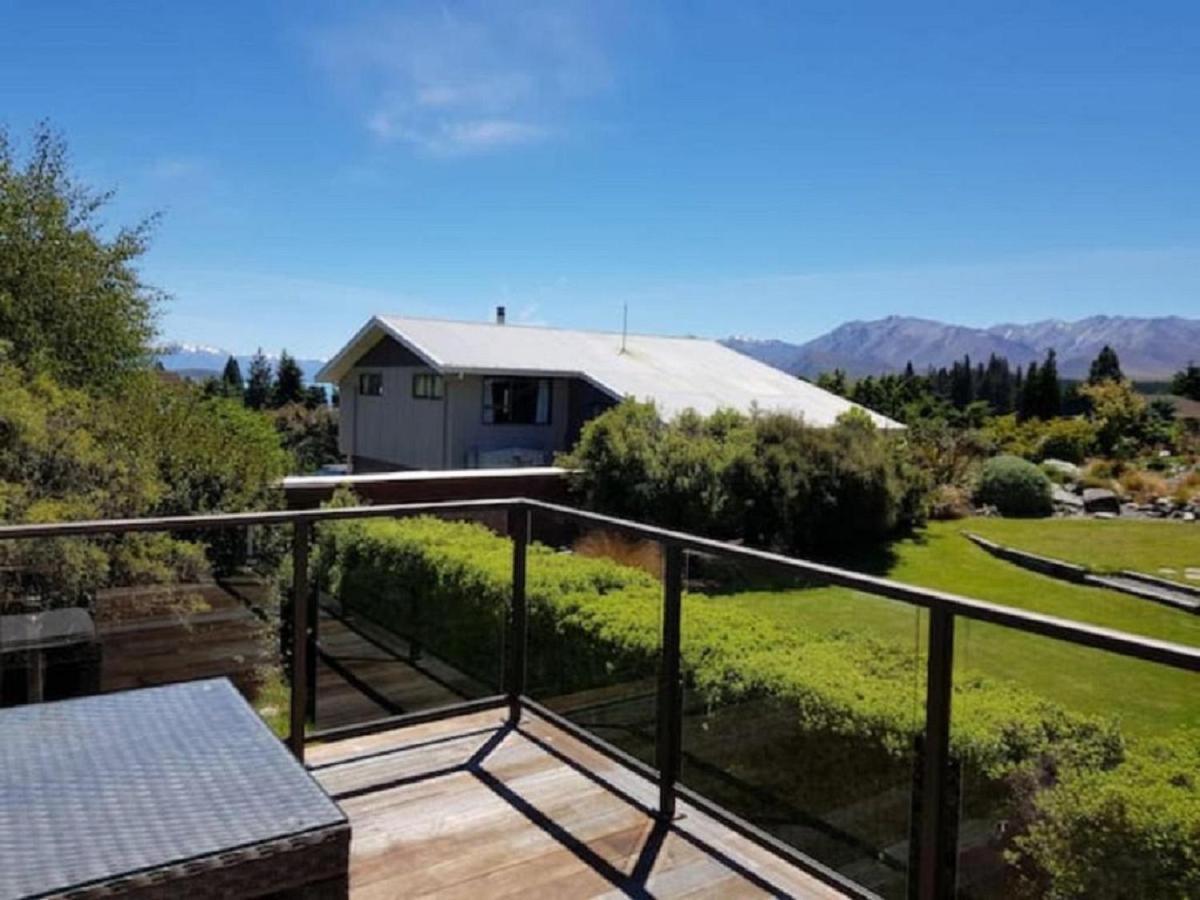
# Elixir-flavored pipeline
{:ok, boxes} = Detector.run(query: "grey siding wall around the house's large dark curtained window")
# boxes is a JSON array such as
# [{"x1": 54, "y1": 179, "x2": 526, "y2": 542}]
[{"x1": 446, "y1": 376, "x2": 569, "y2": 468}]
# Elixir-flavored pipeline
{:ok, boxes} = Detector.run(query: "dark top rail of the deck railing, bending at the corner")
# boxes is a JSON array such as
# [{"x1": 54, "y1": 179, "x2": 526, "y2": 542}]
[{"x1": 7, "y1": 497, "x2": 1200, "y2": 672}]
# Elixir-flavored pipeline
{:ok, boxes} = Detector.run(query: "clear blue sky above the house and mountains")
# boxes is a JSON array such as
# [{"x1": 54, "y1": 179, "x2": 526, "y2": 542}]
[{"x1": 0, "y1": 0, "x2": 1200, "y2": 355}]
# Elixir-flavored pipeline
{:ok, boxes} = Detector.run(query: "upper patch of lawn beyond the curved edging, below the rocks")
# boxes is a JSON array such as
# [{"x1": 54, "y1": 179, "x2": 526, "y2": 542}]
[{"x1": 952, "y1": 518, "x2": 1200, "y2": 586}]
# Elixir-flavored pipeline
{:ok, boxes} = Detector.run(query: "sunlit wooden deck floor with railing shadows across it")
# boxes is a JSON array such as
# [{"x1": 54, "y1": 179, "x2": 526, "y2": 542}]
[{"x1": 307, "y1": 709, "x2": 841, "y2": 900}]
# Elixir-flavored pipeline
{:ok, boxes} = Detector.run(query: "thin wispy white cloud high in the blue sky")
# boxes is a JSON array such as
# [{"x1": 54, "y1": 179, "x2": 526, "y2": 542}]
[{"x1": 310, "y1": 0, "x2": 612, "y2": 156}]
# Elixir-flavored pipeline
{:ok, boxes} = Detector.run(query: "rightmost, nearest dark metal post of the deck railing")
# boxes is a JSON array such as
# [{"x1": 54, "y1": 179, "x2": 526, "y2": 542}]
[{"x1": 908, "y1": 607, "x2": 958, "y2": 900}]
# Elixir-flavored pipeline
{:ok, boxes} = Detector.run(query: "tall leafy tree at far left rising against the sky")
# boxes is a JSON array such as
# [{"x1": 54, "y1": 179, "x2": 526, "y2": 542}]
[{"x1": 0, "y1": 125, "x2": 163, "y2": 388}]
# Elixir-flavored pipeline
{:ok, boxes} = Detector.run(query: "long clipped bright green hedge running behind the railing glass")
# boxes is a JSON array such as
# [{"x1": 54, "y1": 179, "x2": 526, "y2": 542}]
[{"x1": 317, "y1": 518, "x2": 1200, "y2": 896}]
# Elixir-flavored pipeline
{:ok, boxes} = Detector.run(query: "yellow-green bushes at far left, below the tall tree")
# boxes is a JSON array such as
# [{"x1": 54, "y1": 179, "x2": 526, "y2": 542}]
[{"x1": 0, "y1": 365, "x2": 287, "y2": 602}]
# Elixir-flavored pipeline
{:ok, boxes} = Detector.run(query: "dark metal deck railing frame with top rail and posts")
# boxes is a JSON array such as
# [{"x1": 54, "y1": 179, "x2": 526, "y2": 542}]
[{"x1": 0, "y1": 498, "x2": 1200, "y2": 899}]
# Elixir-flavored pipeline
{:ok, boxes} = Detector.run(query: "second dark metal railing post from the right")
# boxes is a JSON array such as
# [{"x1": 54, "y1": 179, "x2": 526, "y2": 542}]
[{"x1": 655, "y1": 544, "x2": 683, "y2": 821}]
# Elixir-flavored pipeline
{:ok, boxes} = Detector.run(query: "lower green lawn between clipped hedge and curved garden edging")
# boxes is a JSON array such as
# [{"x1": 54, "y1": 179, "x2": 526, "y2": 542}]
[{"x1": 700, "y1": 521, "x2": 1200, "y2": 734}]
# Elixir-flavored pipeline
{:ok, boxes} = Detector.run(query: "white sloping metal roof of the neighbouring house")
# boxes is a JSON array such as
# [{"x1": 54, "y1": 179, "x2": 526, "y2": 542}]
[{"x1": 317, "y1": 316, "x2": 900, "y2": 428}]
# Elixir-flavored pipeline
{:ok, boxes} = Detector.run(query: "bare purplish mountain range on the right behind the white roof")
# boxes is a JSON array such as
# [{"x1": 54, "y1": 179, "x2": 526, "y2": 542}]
[{"x1": 724, "y1": 316, "x2": 1200, "y2": 380}]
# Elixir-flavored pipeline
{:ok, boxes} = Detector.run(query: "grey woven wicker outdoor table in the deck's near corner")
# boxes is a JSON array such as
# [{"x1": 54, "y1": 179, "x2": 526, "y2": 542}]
[{"x1": 0, "y1": 678, "x2": 350, "y2": 900}]
